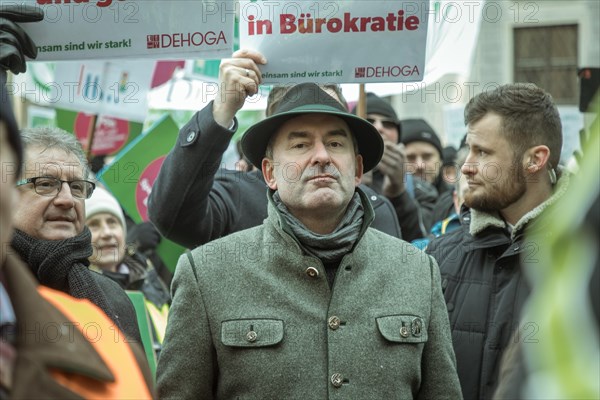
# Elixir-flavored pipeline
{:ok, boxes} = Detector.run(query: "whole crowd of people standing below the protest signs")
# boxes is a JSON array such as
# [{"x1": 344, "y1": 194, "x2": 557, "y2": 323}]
[{"x1": 0, "y1": 6, "x2": 600, "y2": 399}]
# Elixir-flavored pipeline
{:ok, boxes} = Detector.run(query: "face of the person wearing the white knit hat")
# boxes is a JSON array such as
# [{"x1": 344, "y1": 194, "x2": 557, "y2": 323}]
[{"x1": 86, "y1": 213, "x2": 125, "y2": 272}]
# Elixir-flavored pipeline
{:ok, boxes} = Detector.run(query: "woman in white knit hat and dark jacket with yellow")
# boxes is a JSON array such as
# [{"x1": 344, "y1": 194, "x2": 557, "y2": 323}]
[{"x1": 85, "y1": 186, "x2": 171, "y2": 351}]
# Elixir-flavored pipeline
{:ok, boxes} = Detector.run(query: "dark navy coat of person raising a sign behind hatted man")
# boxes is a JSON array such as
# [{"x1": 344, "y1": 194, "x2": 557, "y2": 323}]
[{"x1": 148, "y1": 102, "x2": 401, "y2": 248}]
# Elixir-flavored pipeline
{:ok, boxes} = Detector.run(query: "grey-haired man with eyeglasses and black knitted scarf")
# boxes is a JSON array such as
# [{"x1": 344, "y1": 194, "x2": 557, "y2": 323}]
[{"x1": 12, "y1": 128, "x2": 140, "y2": 342}]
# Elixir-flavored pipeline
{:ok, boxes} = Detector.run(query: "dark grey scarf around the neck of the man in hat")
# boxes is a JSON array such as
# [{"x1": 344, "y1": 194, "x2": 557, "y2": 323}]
[{"x1": 273, "y1": 192, "x2": 365, "y2": 263}]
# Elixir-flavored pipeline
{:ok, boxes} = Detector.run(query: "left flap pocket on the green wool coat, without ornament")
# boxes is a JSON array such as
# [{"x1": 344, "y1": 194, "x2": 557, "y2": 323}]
[{"x1": 221, "y1": 319, "x2": 283, "y2": 347}]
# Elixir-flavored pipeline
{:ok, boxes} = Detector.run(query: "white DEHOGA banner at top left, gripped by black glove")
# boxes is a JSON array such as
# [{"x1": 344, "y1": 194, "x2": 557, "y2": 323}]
[{"x1": 0, "y1": 0, "x2": 235, "y2": 61}]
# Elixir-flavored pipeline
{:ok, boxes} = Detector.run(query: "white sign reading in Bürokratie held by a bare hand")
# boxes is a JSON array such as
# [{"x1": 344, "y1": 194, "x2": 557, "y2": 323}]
[{"x1": 240, "y1": 0, "x2": 429, "y2": 84}]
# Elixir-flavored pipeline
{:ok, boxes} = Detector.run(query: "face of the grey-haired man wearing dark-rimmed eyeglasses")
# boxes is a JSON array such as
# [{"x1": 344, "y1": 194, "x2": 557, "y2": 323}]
[{"x1": 14, "y1": 146, "x2": 86, "y2": 240}]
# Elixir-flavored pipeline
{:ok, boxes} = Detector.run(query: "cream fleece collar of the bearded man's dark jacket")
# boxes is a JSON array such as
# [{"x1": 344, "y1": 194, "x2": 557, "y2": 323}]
[{"x1": 469, "y1": 171, "x2": 569, "y2": 240}]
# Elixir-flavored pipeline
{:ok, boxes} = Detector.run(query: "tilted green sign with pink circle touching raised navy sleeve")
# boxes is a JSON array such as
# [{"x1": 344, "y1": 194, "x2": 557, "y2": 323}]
[{"x1": 98, "y1": 115, "x2": 185, "y2": 271}]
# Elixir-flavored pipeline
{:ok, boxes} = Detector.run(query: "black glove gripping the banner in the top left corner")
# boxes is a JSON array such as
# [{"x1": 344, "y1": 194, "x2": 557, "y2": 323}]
[{"x1": 0, "y1": 5, "x2": 44, "y2": 74}]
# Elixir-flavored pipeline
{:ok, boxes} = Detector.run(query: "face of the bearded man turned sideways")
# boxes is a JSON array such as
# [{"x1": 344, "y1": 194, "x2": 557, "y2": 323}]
[{"x1": 461, "y1": 113, "x2": 526, "y2": 212}]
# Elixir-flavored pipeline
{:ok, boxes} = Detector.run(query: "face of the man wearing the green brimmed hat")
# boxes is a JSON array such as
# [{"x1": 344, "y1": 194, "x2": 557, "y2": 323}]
[{"x1": 263, "y1": 114, "x2": 363, "y2": 228}]
